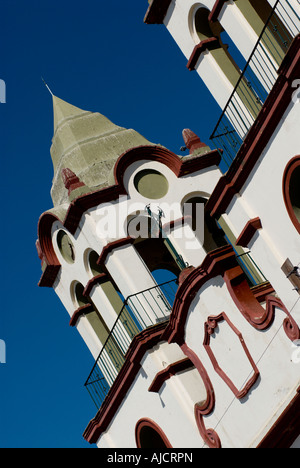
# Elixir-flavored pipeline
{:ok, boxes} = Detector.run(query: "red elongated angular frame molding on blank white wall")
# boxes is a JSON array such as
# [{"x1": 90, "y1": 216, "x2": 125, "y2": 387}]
[{"x1": 203, "y1": 312, "x2": 259, "y2": 400}]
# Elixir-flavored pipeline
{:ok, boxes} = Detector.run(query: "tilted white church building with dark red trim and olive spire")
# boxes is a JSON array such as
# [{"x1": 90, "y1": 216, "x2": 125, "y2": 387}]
[{"x1": 36, "y1": 0, "x2": 300, "y2": 449}]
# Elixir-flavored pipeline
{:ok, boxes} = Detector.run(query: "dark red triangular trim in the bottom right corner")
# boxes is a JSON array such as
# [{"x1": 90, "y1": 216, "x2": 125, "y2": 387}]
[{"x1": 257, "y1": 387, "x2": 300, "y2": 448}]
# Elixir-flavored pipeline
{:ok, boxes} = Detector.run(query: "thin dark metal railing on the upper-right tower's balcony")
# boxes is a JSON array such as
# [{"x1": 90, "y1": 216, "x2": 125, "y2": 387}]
[{"x1": 210, "y1": 0, "x2": 300, "y2": 171}]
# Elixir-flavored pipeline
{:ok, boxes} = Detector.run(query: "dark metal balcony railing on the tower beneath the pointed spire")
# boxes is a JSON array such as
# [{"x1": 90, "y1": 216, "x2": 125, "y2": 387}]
[{"x1": 85, "y1": 280, "x2": 178, "y2": 409}]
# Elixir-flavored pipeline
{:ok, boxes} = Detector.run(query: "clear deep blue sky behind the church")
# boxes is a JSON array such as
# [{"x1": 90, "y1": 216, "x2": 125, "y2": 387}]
[{"x1": 0, "y1": 0, "x2": 220, "y2": 448}]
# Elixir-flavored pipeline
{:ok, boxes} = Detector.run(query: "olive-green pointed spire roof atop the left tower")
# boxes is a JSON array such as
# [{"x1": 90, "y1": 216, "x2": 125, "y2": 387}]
[{"x1": 50, "y1": 95, "x2": 151, "y2": 206}]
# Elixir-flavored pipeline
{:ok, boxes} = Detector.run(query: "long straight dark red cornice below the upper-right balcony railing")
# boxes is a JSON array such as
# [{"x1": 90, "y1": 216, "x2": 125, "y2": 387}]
[{"x1": 207, "y1": 34, "x2": 300, "y2": 218}]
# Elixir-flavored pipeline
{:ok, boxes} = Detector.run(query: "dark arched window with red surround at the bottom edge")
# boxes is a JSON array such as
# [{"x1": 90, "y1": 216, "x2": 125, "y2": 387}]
[{"x1": 135, "y1": 419, "x2": 173, "y2": 449}]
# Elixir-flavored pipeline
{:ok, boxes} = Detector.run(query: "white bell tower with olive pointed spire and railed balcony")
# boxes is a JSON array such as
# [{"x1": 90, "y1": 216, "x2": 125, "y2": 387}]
[{"x1": 37, "y1": 96, "x2": 225, "y2": 424}]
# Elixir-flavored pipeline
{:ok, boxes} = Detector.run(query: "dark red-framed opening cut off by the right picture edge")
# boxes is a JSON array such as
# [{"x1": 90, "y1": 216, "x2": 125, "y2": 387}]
[{"x1": 283, "y1": 156, "x2": 300, "y2": 233}]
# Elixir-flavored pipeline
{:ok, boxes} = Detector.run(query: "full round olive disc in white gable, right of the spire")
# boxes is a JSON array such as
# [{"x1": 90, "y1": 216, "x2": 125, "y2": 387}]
[{"x1": 134, "y1": 169, "x2": 169, "y2": 200}]
